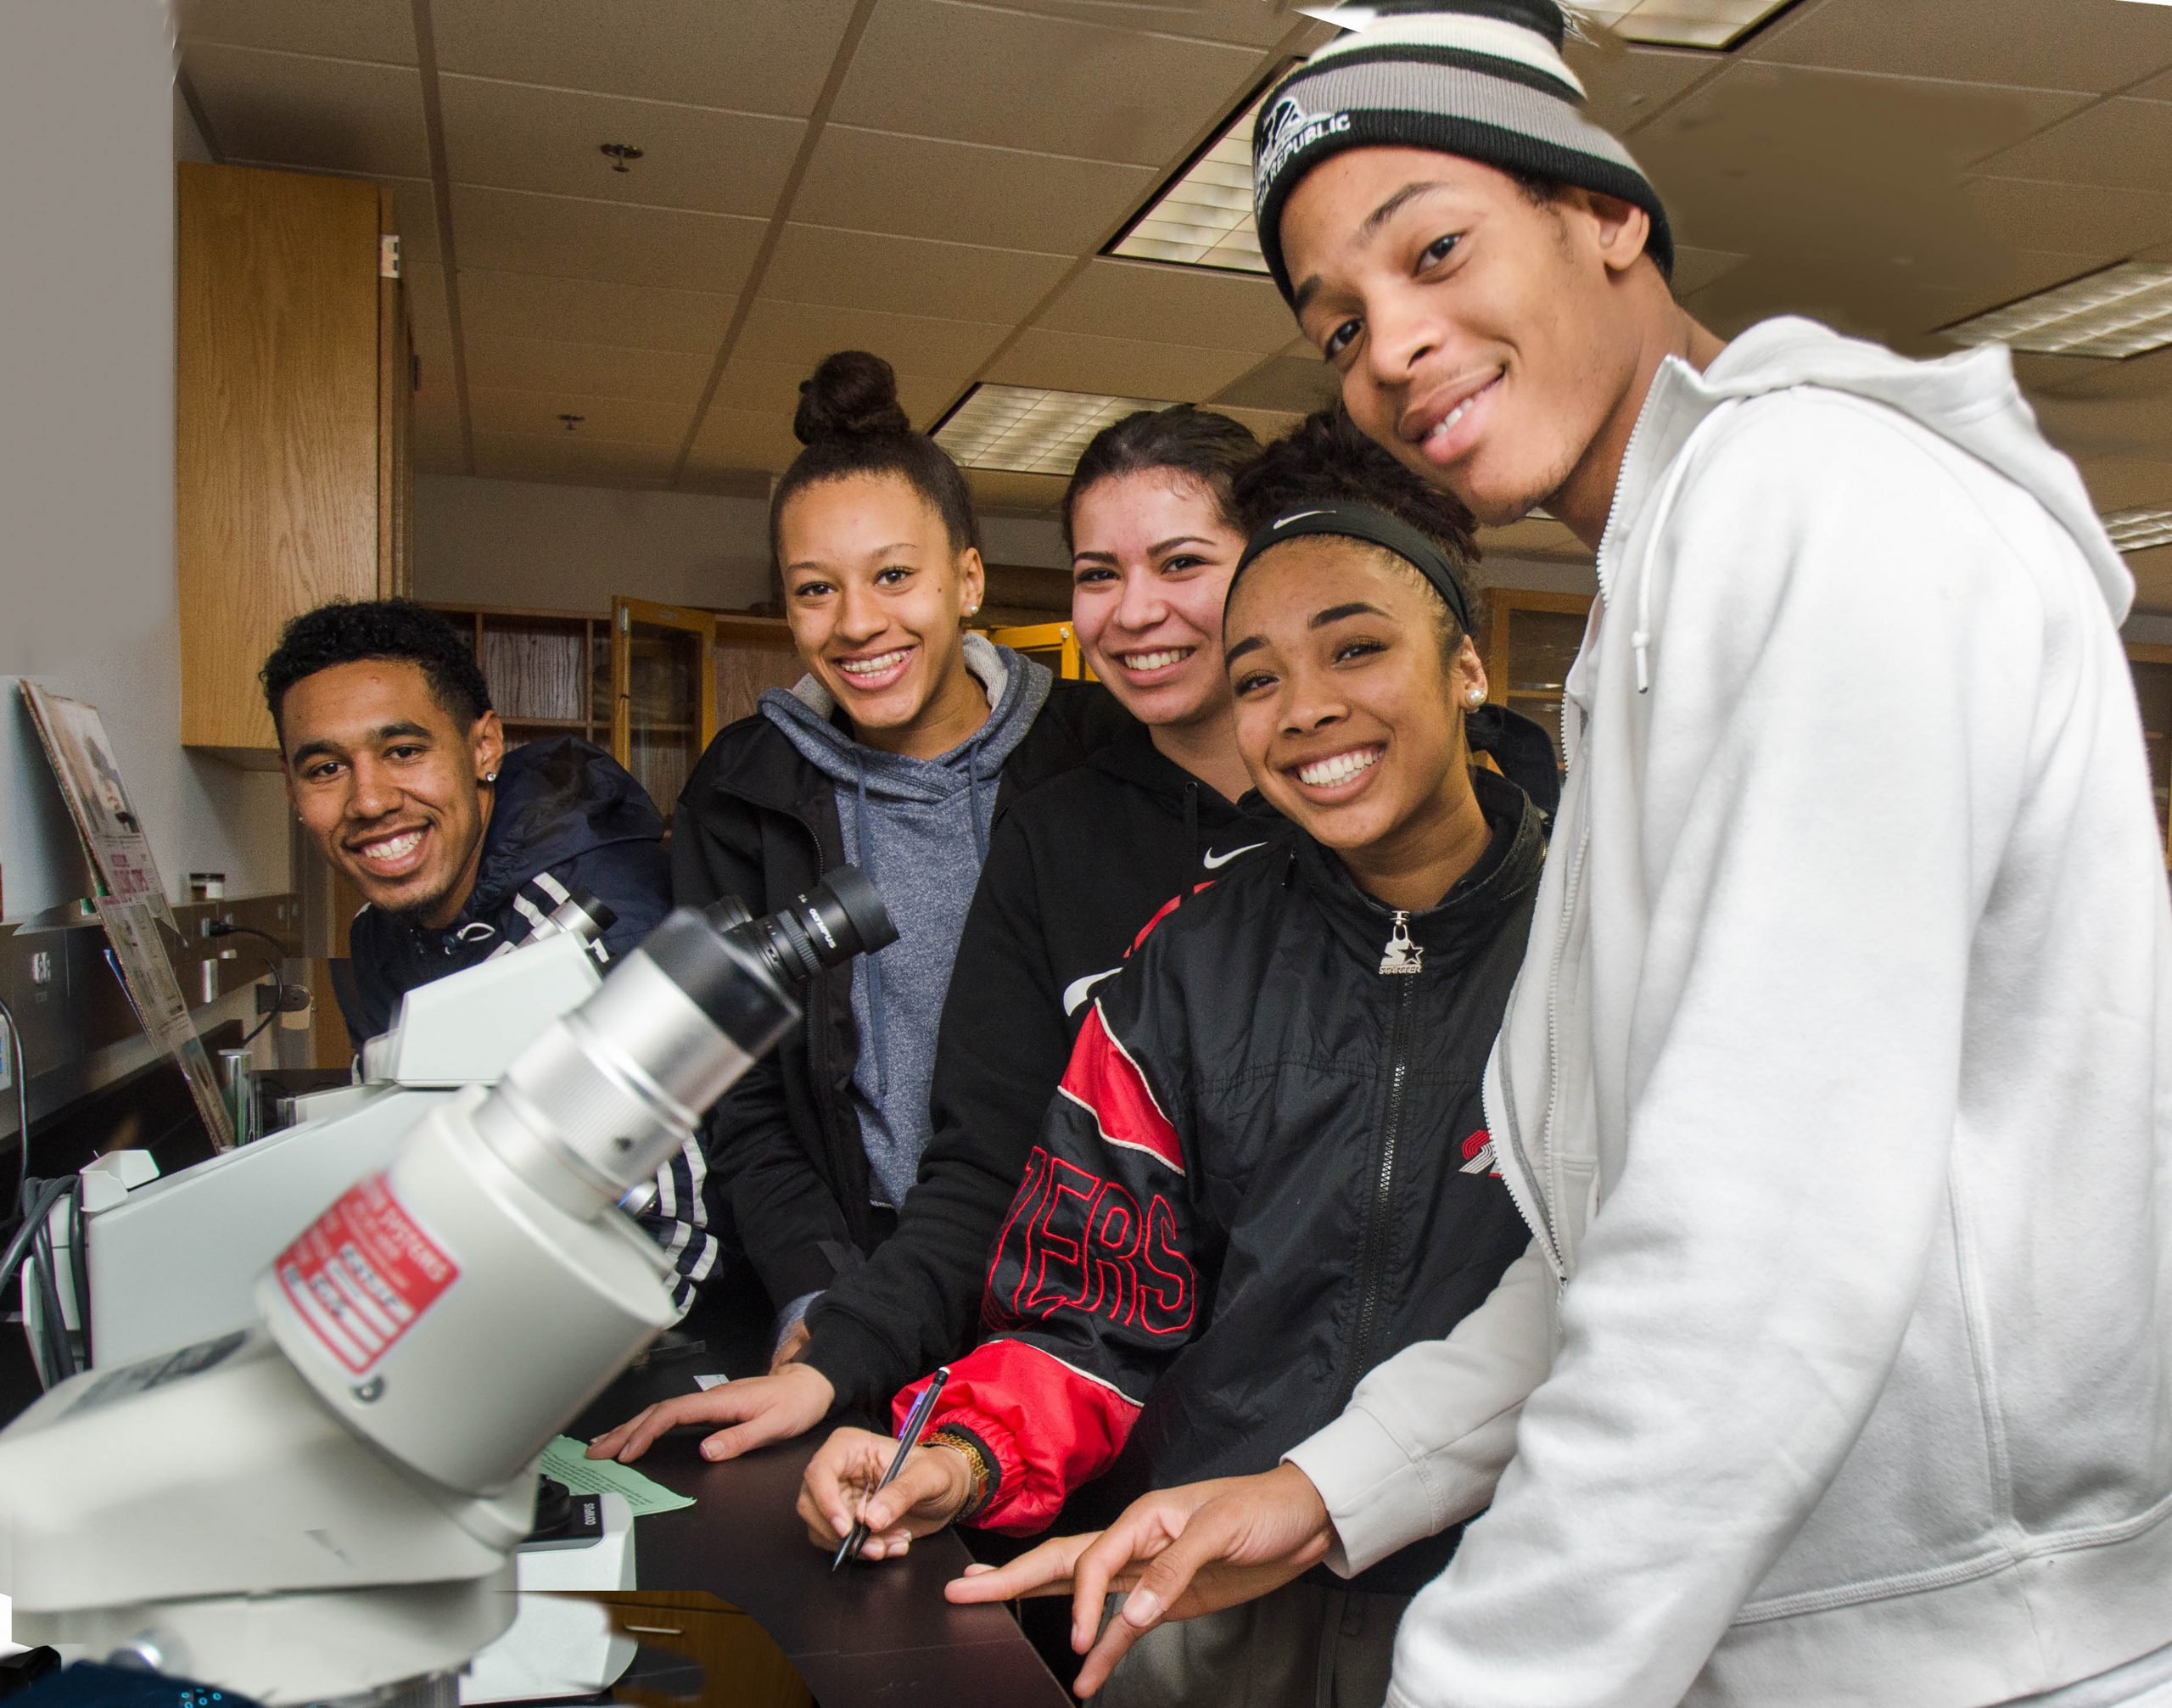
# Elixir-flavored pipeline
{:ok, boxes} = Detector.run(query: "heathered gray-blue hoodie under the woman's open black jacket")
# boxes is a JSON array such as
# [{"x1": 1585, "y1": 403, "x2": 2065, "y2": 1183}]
[{"x1": 763, "y1": 635, "x2": 1051, "y2": 1208}]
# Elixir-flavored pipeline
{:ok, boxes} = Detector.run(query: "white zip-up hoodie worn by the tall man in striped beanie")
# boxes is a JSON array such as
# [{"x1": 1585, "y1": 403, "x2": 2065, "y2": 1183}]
[{"x1": 1290, "y1": 319, "x2": 2172, "y2": 1708}]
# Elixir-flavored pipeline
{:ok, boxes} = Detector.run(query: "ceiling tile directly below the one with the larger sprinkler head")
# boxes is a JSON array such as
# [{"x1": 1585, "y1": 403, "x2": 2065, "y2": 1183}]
[{"x1": 451, "y1": 185, "x2": 767, "y2": 295}]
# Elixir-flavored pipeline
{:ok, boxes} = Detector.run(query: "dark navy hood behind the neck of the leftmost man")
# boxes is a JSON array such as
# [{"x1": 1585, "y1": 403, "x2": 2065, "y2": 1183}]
[{"x1": 475, "y1": 735, "x2": 664, "y2": 921}]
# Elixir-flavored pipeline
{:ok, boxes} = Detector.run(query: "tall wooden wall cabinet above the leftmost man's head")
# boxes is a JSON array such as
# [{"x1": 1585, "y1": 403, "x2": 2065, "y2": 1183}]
[{"x1": 174, "y1": 163, "x2": 412, "y2": 764}]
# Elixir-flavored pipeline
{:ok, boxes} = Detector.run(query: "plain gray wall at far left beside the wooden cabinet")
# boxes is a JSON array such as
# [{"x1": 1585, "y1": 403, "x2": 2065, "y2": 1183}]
[{"x1": 0, "y1": 0, "x2": 288, "y2": 917}]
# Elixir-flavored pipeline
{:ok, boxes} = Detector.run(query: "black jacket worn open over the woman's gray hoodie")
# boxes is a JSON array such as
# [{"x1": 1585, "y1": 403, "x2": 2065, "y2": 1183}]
[{"x1": 671, "y1": 682, "x2": 1129, "y2": 1308}]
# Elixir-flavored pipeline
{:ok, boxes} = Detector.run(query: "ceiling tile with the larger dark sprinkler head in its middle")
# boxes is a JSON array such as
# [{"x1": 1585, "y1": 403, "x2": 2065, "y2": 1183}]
[{"x1": 436, "y1": 76, "x2": 806, "y2": 217}]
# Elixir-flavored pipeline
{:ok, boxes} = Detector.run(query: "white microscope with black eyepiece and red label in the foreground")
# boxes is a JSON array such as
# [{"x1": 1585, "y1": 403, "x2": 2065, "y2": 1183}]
[{"x1": 0, "y1": 867, "x2": 897, "y2": 1708}]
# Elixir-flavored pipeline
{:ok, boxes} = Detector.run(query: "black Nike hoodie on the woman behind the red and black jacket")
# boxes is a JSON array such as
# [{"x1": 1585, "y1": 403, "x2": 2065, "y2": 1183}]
[{"x1": 802, "y1": 706, "x2": 1559, "y2": 1410}]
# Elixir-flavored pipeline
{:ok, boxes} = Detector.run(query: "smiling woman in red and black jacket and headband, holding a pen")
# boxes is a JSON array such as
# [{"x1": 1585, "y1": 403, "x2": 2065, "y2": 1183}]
[{"x1": 802, "y1": 419, "x2": 1553, "y2": 1704}]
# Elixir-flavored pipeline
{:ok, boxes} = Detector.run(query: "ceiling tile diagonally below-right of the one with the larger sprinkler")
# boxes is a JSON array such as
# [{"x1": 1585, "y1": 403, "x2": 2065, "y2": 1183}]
[{"x1": 763, "y1": 226, "x2": 1073, "y2": 324}]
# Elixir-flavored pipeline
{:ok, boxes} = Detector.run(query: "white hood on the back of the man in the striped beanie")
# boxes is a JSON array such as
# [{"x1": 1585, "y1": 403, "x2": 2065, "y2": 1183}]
[{"x1": 1598, "y1": 315, "x2": 2135, "y2": 628}]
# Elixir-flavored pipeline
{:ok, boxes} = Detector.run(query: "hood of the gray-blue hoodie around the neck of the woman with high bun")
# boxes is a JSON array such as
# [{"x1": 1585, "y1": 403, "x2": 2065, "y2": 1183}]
[{"x1": 763, "y1": 632, "x2": 1054, "y2": 802}]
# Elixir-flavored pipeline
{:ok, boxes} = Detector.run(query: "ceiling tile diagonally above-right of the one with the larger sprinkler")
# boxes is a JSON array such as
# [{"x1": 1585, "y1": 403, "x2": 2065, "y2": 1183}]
[{"x1": 831, "y1": 0, "x2": 1266, "y2": 167}]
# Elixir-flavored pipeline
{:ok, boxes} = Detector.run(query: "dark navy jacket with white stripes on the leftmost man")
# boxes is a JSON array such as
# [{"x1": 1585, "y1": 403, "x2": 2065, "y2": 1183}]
[{"x1": 339, "y1": 735, "x2": 717, "y2": 1310}]
